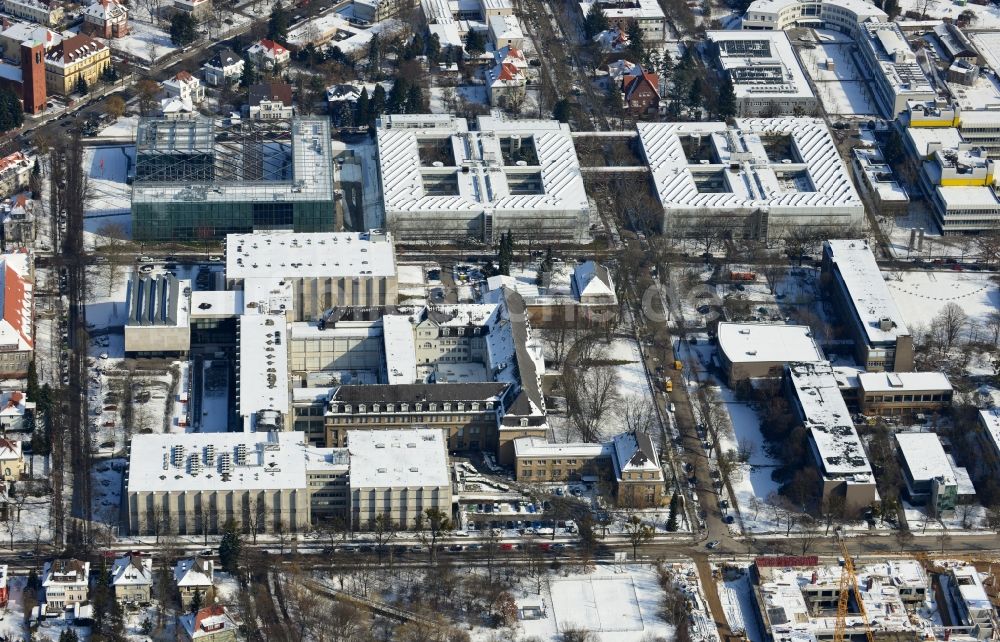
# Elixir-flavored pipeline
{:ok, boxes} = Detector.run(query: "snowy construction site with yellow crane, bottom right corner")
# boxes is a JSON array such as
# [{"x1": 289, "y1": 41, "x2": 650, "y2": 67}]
[{"x1": 720, "y1": 545, "x2": 1000, "y2": 642}]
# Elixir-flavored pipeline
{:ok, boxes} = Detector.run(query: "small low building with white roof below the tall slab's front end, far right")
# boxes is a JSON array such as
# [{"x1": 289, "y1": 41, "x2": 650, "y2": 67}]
[{"x1": 858, "y1": 372, "x2": 952, "y2": 416}]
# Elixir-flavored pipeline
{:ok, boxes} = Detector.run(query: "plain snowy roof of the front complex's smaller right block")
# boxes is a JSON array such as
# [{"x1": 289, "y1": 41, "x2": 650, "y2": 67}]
[{"x1": 347, "y1": 428, "x2": 451, "y2": 488}]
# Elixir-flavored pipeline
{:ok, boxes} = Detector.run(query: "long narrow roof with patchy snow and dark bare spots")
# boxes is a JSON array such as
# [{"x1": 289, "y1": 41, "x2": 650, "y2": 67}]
[{"x1": 788, "y1": 361, "x2": 872, "y2": 480}]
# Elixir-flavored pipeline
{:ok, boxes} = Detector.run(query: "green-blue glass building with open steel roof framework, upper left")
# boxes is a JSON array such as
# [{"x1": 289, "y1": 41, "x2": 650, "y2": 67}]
[{"x1": 132, "y1": 117, "x2": 335, "y2": 240}]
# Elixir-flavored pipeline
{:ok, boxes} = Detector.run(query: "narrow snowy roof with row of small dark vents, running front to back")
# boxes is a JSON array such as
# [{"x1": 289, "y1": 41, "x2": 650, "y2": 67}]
[{"x1": 237, "y1": 314, "x2": 289, "y2": 420}]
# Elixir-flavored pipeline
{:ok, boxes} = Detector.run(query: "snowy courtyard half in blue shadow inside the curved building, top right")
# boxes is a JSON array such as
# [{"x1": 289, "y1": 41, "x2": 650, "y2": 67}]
[{"x1": 799, "y1": 29, "x2": 878, "y2": 116}]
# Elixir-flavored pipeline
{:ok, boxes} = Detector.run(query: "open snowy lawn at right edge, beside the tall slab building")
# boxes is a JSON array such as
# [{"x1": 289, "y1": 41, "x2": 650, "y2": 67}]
[{"x1": 883, "y1": 270, "x2": 1000, "y2": 329}]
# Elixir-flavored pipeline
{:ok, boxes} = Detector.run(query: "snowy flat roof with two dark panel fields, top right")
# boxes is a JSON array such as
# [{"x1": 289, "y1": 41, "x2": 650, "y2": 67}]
[{"x1": 705, "y1": 29, "x2": 813, "y2": 100}]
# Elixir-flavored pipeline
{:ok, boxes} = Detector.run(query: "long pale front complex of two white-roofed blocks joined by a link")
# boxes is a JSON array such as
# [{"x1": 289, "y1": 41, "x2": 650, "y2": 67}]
[{"x1": 125, "y1": 427, "x2": 452, "y2": 535}]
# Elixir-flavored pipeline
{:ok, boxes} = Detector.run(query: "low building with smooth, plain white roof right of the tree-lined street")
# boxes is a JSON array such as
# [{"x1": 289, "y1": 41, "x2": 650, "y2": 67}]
[{"x1": 716, "y1": 323, "x2": 823, "y2": 386}]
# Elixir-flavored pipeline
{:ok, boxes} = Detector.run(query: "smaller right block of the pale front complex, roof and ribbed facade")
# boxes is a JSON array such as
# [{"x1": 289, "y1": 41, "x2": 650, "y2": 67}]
[{"x1": 347, "y1": 428, "x2": 452, "y2": 529}]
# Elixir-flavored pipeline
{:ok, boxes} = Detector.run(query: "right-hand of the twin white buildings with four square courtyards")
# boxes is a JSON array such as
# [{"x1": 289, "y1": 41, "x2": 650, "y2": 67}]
[{"x1": 638, "y1": 117, "x2": 864, "y2": 239}]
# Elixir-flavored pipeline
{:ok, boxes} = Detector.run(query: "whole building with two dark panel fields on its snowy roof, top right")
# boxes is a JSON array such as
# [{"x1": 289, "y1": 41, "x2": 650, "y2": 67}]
[{"x1": 706, "y1": 30, "x2": 819, "y2": 116}]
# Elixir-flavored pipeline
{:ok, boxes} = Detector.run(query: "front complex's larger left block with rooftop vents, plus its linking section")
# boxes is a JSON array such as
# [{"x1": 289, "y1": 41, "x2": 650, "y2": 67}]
[{"x1": 125, "y1": 432, "x2": 348, "y2": 535}]
